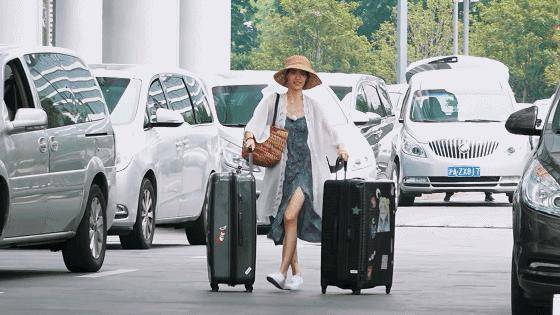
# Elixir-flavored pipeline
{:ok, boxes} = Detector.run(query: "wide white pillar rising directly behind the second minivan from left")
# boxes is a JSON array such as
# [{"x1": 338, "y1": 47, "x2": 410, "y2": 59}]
[{"x1": 103, "y1": 0, "x2": 179, "y2": 66}]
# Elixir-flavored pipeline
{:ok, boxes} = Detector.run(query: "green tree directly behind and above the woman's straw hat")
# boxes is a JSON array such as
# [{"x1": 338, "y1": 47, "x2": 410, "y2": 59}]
[{"x1": 246, "y1": 0, "x2": 371, "y2": 72}]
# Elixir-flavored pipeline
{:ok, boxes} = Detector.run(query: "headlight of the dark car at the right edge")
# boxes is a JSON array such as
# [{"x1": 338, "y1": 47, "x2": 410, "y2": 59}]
[{"x1": 521, "y1": 160, "x2": 560, "y2": 216}]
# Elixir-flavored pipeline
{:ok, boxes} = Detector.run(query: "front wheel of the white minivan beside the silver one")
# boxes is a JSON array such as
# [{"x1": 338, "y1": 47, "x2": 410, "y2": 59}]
[{"x1": 120, "y1": 178, "x2": 156, "y2": 249}]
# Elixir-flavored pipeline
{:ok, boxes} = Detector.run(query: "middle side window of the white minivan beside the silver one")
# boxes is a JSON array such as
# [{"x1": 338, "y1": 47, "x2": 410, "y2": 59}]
[{"x1": 162, "y1": 76, "x2": 195, "y2": 124}]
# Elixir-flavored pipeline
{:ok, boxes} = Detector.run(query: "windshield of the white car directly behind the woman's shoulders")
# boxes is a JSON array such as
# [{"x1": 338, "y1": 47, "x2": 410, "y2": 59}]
[{"x1": 212, "y1": 84, "x2": 348, "y2": 127}]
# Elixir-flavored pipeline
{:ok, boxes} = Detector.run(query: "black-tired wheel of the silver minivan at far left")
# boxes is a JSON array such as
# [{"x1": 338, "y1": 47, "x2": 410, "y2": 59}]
[{"x1": 62, "y1": 184, "x2": 107, "y2": 272}]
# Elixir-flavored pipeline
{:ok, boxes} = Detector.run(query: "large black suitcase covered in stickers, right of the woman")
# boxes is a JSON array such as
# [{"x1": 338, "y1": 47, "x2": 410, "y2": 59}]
[{"x1": 321, "y1": 163, "x2": 396, "y2": 294}]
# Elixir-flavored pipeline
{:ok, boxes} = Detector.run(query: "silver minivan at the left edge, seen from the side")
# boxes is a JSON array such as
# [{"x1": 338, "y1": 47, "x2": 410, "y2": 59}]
[{"x1": 0, "y1": 46, "x2": 115, "y2": 272}]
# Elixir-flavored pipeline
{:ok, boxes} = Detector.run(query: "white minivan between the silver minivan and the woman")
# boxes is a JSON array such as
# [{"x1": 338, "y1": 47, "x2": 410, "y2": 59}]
[{"x1": 92, "y1": 64, "x2": 220, "y2": 249}]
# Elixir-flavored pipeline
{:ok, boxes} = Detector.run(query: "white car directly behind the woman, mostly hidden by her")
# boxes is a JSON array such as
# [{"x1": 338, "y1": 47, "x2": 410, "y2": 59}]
[{"x1": 201, "y1": 71, "x2": 377, "y2": 225}]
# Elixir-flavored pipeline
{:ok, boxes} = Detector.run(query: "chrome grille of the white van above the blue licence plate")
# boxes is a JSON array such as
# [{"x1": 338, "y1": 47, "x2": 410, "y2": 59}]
[{"x1": 430, "y1": 139, "x2": 499, "y2": 159}]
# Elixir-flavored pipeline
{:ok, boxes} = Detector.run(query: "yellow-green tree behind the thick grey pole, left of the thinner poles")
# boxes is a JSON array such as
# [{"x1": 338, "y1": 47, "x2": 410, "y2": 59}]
[{"x1": 372, "y1": 0, "x2": 453, "y2": 83}]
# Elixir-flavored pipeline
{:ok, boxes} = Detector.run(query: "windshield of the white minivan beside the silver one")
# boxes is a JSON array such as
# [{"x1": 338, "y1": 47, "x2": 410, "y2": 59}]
[{"x1": 97, "y1": 77, "x2": 140, "y2": 125}]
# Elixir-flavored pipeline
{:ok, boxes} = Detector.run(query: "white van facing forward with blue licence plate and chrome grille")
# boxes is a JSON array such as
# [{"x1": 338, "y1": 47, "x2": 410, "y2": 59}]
[{"x1": 395, "y1": 69, "x2": 531, "y2": 206}]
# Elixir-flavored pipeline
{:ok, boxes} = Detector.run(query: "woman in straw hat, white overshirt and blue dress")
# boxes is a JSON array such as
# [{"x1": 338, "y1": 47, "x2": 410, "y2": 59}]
[{"x1": 243, "y1": 56, "x2": 348, "y2": 290}]
